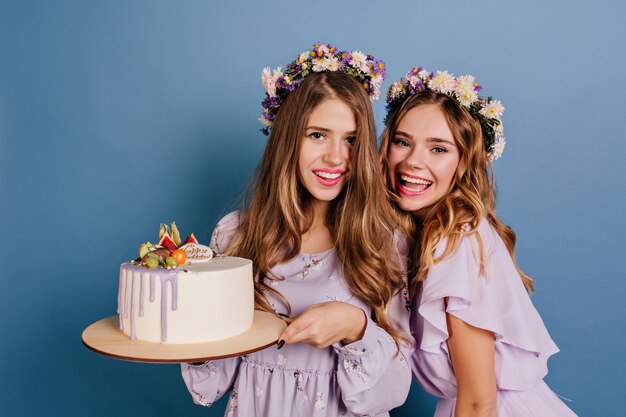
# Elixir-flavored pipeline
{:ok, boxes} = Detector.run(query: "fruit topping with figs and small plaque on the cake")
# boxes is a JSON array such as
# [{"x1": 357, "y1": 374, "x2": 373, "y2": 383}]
[{"x1": 132, "y1": 222, "x2": 213, "y2": 269}]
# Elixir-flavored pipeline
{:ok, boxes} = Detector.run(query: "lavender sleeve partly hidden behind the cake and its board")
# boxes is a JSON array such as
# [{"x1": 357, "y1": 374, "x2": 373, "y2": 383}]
[{"x1": 180, "y1": 211, "x2": 241, "y2": 407}]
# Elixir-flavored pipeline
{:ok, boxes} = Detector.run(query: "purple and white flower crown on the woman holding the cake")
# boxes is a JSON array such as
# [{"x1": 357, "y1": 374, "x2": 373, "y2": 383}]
[{"x1": 259, "y1": 43, "x2": 385, "y2": 136}]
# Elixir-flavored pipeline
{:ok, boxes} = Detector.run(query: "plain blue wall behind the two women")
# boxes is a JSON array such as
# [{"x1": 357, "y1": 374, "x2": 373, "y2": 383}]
[{"x1": 0, "y1": 0, "x2": 626, "y2": 417}]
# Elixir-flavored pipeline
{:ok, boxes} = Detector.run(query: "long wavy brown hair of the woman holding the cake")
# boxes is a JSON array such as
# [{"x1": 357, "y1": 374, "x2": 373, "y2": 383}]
[{"x1": 226, "y1": 72, "x2": 405, "y2": 344}]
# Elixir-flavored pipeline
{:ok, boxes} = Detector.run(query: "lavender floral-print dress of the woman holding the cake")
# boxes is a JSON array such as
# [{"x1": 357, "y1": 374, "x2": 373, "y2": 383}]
[{"x1": 181, "y1": 212, "x2": 412, "y2": 417}]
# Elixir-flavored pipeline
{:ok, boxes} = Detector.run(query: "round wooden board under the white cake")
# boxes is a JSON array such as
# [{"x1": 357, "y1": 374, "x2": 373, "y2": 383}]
[{"x1": 82, "y1": 310, "x2": 287, "y2": 363}]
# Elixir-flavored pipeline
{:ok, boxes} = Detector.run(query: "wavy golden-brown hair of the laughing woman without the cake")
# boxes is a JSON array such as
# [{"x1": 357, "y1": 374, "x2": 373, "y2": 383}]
[{"x1": 380, "y1": 90, "x2": 533, "y2": 295}]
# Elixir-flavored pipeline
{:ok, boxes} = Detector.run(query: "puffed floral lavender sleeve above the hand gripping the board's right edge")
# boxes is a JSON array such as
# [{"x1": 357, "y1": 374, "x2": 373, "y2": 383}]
[{"x1": 334, "y1": 231, "x2": 414, "y2": 415}]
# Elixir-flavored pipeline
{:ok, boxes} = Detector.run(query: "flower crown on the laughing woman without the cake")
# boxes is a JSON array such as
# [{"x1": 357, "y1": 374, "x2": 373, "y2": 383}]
[{"x1": 385, "y1": 67, "x2": 505, "y2": 161}]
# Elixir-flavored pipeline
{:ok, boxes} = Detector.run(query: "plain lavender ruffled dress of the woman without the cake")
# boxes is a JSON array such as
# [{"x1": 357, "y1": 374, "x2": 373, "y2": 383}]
[{"x1": 411, "y1": 220, "x2": 575, "y2": 417}]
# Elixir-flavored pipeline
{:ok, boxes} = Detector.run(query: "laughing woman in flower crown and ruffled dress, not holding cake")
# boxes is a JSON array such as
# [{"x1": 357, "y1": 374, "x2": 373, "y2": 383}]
[{"x1": 381, "y1": 68, "x2": 574, "y2": 417}]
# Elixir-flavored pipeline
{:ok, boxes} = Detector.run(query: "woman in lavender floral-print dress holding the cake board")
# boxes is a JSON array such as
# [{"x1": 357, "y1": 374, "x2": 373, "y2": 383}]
[{"x1": 182, "y1": 44, "x2": 412, "y2": 416}]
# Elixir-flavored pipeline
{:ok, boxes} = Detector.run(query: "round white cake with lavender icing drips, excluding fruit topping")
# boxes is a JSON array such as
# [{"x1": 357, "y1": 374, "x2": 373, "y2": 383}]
[{"x1": 118, "y1": 257, "x2": 254, "y2": 344}]
